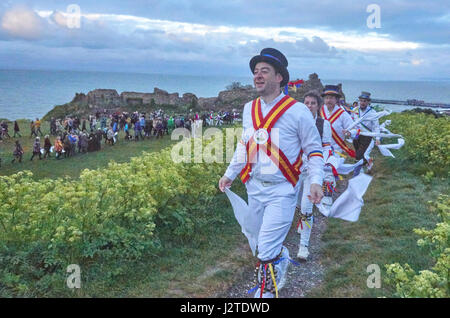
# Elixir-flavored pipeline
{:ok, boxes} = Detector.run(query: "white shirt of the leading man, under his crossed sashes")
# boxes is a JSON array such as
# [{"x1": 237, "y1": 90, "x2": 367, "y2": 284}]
[{"x1": 225, "y1": 93, "x2": 324, "y2": 185}]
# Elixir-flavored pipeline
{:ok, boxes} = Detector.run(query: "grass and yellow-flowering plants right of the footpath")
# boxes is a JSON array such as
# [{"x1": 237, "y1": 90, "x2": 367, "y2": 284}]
[{"x1": 310, "y1": 113, "x2": 450, "y2": 297}]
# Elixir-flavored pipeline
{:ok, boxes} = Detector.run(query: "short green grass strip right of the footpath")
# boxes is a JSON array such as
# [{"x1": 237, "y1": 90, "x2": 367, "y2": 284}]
[{"x1": 309, "y1": 157, "x2": 448, "y2": 297}]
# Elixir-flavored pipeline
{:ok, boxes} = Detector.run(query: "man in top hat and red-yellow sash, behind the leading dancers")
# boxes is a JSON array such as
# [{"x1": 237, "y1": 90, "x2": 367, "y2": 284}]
[{"x1": 320, "y1": 85, "x2": 356, "y2": 158}]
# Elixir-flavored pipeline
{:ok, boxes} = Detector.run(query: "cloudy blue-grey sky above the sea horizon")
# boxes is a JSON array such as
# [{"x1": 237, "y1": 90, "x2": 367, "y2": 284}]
[{"x1": 0, "y1": 0, "x2": 450, "y2": 80}]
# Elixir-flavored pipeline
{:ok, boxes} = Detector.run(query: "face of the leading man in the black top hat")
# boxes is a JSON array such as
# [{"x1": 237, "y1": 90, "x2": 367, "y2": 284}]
[{"x1": 253, "y1": 62, "x2": 283, "y2": 95}]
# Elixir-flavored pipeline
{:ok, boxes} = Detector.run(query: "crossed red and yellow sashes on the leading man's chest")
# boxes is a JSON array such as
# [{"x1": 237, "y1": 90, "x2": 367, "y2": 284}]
[{"x1": 240, "y1": 95, "x2": 302, "y2": 187}]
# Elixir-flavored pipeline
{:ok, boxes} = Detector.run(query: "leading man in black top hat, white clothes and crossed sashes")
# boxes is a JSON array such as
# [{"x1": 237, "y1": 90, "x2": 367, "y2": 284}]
[{"x1": 219, "y1": 48, "x2": 324, "y2": 297}]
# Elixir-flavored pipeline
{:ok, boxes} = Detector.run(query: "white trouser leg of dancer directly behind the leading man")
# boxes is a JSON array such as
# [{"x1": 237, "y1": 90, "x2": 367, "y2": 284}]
[{"x1": 297, "y1": 171, "x2": 314, "y2": 246}]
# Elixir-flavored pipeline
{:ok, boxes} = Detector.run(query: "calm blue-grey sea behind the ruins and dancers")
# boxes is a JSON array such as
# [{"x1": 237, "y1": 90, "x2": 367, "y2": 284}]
[{"x1": 0, "y1": 70, "x2": 450, "y2": 120}]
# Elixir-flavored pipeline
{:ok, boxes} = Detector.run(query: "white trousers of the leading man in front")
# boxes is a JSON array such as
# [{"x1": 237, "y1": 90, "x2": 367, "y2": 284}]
[{"x1": 246, "y1": 178, "x2": 299, "y2": 261}]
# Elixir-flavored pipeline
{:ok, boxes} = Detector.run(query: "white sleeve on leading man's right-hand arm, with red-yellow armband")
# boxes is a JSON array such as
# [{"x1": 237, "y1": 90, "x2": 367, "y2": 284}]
[{"x1": 298, "y1": 106, "x2": 324, "y2": 186}]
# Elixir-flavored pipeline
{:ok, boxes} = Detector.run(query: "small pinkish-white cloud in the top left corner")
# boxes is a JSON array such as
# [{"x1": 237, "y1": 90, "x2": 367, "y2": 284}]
[{"x1": 1, "y1": 6, "x2": 44, "y2": 40}]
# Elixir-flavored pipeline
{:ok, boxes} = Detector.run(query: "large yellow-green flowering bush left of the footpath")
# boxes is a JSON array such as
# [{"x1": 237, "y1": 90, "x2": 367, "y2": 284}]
[{"x1": 0, "y1": 141, "x2": 223, "y2": 296}]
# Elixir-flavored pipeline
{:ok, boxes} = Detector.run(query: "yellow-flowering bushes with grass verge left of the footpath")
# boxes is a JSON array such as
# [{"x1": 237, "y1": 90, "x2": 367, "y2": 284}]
[{"x1": 0, "y1": 120, "x2": 251, "y2": 297}]
